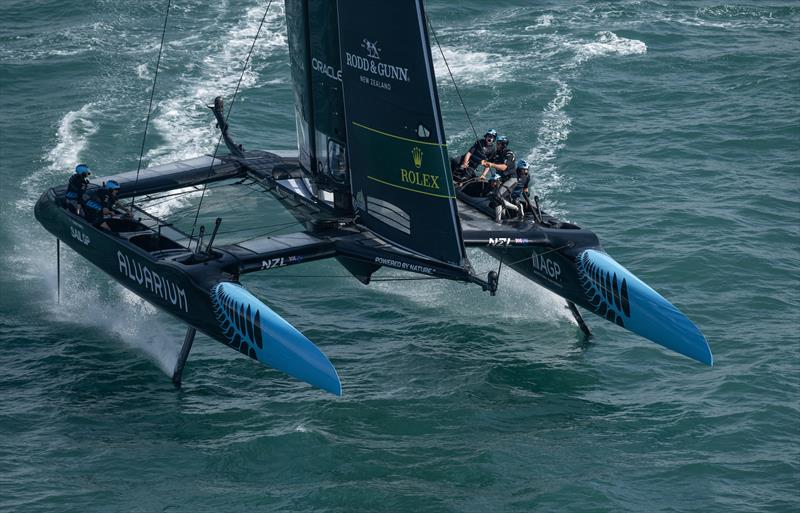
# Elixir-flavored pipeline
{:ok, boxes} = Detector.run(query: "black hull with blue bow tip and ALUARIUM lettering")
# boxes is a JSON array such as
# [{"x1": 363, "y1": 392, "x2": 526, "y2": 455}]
[{"x1": 35, "y1": 189, "x2": 341, "y2": 395}]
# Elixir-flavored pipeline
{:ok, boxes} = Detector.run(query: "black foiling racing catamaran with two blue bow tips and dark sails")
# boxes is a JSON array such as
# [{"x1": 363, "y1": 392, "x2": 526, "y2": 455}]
[{"x1": 35, "y1": 0, "x2": 712, "y2": 395}]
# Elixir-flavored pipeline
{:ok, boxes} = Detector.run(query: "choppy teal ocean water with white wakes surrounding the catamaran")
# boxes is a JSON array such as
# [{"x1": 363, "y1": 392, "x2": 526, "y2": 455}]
[{"x1": 0, "y1": 0, "x2": 800, "y2": 513}]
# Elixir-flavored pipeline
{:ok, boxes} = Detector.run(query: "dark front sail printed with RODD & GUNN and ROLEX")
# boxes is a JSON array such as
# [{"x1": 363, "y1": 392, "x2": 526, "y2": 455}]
[{"x1": 338, "y1": 0, "x2": 464, "y2": 266}]
